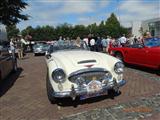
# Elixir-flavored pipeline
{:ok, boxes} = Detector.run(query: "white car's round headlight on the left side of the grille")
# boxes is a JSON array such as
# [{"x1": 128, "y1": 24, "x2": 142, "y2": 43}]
[{"x1": 52, "y1": 68, "x2": 66, "y2": 83}]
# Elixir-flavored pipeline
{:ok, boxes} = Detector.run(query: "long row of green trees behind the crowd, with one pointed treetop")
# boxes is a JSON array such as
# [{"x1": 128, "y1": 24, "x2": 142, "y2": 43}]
[{"x1": 21, "y1": 13, "x2": 128, "y2": 41}]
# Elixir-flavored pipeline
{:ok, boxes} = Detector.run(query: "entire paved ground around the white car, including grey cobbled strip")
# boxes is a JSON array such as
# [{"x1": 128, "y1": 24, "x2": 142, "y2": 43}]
[{"x1": 0, "y1": 54, "x2": 160, "y2": 120}]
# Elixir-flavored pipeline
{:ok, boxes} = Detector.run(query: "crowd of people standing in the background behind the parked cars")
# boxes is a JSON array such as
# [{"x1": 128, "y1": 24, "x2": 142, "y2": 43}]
[{"x1": 10, "y1": 32, "x2": 151, "y2": 59}]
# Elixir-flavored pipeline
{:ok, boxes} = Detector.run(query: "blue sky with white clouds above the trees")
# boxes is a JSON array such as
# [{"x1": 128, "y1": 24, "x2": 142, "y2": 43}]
[{"x1": 17, "y1": 0, "x2": 160, "y2": 30}]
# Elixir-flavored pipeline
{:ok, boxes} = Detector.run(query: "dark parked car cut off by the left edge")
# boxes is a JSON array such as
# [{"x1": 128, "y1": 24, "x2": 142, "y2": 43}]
[{"x1": 0, "y1": 41, "x2": 17, "y2": 81}]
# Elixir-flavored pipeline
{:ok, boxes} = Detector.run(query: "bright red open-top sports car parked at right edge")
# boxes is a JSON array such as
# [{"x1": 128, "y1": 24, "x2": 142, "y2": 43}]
[{"x1": 108, "y1": 38, "x2": 160, "y2": 69}]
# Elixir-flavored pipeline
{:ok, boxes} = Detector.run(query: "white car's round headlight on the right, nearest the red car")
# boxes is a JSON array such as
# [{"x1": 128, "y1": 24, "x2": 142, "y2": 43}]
[{"x1": 114, "y1": 62, "x2": 124, "y2": 74}]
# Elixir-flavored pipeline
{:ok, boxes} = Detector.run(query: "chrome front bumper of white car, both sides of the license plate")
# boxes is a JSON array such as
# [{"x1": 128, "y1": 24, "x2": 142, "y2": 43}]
[{"x1": 52, "y1": 80, "x2": 126, "y2": 98}]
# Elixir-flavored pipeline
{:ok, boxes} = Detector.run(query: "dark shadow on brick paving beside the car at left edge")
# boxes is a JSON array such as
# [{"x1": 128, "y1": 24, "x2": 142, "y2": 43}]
[{"x1": 0, "y1": 68, "x2": 23, "y2": 97}]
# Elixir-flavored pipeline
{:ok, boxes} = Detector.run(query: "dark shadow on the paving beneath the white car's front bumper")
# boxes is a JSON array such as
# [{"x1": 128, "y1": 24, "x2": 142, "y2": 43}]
[{"x1": 57, "y1": 92, "x2": 121, "y2": 107}]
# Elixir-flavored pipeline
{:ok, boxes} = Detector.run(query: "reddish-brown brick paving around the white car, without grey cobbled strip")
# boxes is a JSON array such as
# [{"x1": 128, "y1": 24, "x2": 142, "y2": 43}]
[{"x1": 0, "y1": 54, "x2": 160, "y2": 120}]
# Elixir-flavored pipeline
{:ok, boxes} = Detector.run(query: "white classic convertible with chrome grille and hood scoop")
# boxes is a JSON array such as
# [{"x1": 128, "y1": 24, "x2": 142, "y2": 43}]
[{"x1": 46, "y1": 41, "x2": 126, "y2": 103}]
